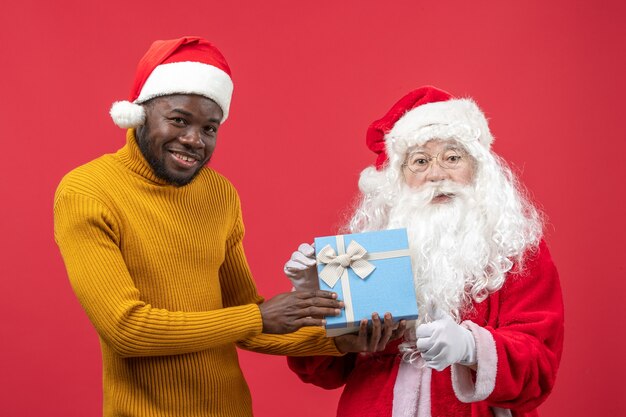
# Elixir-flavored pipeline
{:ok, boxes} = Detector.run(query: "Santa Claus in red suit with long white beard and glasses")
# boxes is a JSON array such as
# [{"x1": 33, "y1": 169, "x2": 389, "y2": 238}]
[{"x1": 285, "y1": 86, "x2": 563, "y2": 417}]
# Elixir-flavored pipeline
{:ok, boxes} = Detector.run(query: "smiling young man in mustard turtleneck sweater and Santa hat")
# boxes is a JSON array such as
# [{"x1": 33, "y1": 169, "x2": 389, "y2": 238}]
[{"x1": 54, "y1": 37, "x2": 372, "y2": 417}]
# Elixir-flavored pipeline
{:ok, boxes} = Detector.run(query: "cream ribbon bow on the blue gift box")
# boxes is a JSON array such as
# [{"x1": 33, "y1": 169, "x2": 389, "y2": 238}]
[{"x1": 317, "y1": 240, "x2": 376, "y2": 288}]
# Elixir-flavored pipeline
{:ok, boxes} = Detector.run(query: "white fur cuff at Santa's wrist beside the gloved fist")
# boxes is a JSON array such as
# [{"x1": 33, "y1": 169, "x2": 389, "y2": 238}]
[{"x1": 451, "y1": 320, "x2": 498, "y2": 403}]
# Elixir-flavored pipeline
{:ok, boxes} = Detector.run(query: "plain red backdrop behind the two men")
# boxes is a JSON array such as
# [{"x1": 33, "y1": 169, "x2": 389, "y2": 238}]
[{"x1": 0, "y1": 0, "x2": 626, "y2": 417}]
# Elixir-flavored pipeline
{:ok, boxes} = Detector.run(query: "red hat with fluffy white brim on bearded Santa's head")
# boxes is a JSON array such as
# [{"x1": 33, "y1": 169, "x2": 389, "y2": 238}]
[{"x1": 366, "y1": 86, "x2": 493, "y2": 171}]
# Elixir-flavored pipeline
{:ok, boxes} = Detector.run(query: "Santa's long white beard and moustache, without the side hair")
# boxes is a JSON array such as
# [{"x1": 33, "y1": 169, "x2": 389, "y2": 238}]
[{"x1": 388, "y1": 181, "x2": 491, "y2": 323}]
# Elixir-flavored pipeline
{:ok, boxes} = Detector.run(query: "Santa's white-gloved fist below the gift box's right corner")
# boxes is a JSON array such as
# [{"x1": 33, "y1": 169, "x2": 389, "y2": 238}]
[{"x1": 416, "y1": 312, "x2": 476, "y2": 371}]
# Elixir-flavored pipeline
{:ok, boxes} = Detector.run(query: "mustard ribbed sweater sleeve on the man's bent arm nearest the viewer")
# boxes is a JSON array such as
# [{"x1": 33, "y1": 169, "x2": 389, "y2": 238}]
[{"x1": 54, "y1": 190, "x2": 262, "y2": 357}]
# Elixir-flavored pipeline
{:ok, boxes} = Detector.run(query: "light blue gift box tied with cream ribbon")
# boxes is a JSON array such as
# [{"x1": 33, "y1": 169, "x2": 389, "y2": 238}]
[{"x1": 315, "y1": 229, "x2": 417, "y2": 336}]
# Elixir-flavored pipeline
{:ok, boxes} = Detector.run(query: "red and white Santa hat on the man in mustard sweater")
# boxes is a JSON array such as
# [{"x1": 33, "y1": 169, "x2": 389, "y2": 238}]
[{"x1": 110, "y1": 36, "x2": 233, "y2": 128}]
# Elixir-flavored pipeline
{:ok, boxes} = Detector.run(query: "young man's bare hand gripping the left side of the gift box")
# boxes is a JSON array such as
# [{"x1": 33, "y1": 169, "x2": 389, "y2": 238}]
[{"x1": 259, "y1": 290, "x2": 344, "y2": 334}]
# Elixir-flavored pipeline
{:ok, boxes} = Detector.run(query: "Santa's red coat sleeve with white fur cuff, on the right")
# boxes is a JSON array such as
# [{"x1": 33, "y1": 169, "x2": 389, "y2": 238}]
[{"x1": 452, "y1": 242, "x2": 564, "y2": 411}]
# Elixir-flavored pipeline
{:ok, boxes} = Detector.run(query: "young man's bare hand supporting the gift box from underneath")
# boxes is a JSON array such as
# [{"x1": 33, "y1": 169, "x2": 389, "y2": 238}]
[{"x1": 335, "y1": 313, "x2": 406, "y2": 353}]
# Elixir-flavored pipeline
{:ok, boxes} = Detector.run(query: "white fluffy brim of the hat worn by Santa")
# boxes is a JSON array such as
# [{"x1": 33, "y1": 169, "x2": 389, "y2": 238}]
[{"x1": 385, "y1": 99, "x2": 493, "y2": 158}]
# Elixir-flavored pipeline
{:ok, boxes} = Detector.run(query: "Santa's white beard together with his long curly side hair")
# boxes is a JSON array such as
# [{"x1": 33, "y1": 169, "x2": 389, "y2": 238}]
[{"x1": 349, "y1": 152, "x2": 542, "y2": 324}]
